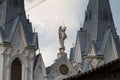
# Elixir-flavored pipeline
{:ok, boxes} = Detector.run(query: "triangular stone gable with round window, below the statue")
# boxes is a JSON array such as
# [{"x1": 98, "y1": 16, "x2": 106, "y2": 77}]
[{"x1": 48, "y1": 56, "x2": 77, "y2": 80}]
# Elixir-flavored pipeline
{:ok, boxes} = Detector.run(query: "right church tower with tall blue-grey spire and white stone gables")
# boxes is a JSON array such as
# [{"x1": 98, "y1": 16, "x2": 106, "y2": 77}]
[{"x1": 70, "y1": 0, "x2": 120, "y2": 72}]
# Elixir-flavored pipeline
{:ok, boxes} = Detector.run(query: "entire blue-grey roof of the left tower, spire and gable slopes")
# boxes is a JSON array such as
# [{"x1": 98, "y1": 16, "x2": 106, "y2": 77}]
[{"x1": 0, "y1": 0, "x2": 38, "y2": 47}]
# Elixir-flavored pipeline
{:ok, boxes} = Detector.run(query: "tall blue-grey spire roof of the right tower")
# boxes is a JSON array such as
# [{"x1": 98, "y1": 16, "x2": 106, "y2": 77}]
[{"x1": 83, "y1": 0, "x2": 118, "y2": 47}]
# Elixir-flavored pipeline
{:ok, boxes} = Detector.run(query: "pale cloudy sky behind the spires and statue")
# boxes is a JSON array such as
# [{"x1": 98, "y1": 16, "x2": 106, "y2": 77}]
[{"x1": 25, "y1": 0, "x2": 120, "y2": 67}]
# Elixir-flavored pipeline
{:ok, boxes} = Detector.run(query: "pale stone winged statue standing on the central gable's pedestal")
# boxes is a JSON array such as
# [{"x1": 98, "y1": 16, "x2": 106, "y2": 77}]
[{"x1": 59, "y1": 26, "x2": 67, "y2": 50}]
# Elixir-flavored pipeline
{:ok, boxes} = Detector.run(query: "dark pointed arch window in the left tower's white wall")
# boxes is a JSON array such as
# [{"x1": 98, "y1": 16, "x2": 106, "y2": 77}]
[{"x1": 11, "y1": 58, "x2": 22, "y2": 80}]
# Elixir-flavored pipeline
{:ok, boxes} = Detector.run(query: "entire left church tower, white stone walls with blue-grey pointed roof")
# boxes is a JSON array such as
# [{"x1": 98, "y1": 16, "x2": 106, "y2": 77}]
[{"x1": 0, "y1": 0, "x2": 46, "y2": 80}]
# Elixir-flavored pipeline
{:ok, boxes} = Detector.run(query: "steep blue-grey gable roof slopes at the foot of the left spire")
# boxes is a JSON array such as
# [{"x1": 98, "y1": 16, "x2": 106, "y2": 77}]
[{"x1": 0, "y1": 16, "x2": 38, "y2": 50}]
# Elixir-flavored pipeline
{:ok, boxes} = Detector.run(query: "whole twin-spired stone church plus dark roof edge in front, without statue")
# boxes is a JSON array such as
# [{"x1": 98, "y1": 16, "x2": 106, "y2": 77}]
[{"x1": 0, "y1": 0, "x2": 120, "y2": 80}]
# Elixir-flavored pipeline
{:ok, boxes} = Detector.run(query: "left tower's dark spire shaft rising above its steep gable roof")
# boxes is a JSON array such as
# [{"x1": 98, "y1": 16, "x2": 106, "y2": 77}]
[{"x1": 0, "y1": 0, "x2": 26, "y2": 35}]
